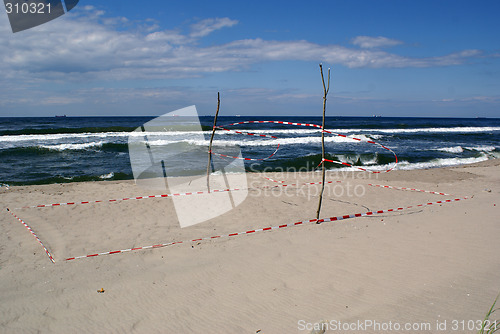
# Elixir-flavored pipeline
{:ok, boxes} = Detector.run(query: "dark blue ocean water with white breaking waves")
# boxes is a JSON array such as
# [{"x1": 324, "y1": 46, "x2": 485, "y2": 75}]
[{"x1": 0, "y1": 116, "x2": 500, "y2": 185}]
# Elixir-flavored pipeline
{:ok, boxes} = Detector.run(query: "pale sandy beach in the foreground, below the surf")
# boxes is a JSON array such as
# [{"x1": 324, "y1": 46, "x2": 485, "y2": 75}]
[{"x1": 0, "y1": 159, "x2": 500, "y2": 333}]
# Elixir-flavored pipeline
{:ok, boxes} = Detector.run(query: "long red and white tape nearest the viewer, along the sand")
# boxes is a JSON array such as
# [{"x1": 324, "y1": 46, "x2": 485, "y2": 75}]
[{"x1": 65, "y1": 197, "x2": 468, "y2": 261}]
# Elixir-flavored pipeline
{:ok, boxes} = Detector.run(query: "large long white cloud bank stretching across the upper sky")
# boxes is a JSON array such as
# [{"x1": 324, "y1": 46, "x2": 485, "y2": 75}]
[{"x1": 0, "y1": 6, "x2": 488, "y2": 83}]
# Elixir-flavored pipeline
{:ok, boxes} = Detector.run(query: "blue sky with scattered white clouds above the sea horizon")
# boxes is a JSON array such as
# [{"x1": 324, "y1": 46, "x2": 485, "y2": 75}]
[{"x1": 0, "y1": 0, "x2": 500, "y2": 117}]
